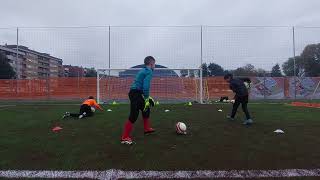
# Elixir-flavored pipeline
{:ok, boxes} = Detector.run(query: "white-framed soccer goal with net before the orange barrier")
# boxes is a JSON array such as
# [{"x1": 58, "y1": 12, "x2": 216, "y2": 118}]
[{"x1": 97, "y1": 68, "x2": 203, "y2": 103}]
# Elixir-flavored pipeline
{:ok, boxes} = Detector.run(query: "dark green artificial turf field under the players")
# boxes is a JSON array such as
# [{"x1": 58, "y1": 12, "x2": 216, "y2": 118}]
[{"x1": 0, "y1": 103, "x2": 320, "y2": 174}]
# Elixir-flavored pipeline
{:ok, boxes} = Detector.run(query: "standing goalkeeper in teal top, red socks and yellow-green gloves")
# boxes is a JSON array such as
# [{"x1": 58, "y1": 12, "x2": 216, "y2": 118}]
[{"x1": 121, "y1": 56, "x2": 156, "y2": 145}]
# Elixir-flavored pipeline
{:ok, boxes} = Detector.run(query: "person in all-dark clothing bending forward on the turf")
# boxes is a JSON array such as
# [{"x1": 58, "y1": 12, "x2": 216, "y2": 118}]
[{"x1": 224, "y1": 74, "x2": 253, "y2": 125}]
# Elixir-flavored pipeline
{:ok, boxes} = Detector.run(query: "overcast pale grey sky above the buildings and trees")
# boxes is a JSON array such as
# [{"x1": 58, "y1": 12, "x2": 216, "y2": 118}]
[{"x1": 0, "y1": 0, "x2": 320, "y2": 70}]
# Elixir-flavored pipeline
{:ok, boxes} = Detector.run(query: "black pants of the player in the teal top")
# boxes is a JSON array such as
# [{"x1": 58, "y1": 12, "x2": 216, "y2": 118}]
[{"x1": 129, "y1": 89, "x2": 150, "y2": 123}]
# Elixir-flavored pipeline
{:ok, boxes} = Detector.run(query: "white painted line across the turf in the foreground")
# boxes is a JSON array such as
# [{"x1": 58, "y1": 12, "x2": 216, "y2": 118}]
[{"x1": 0, "y1": 169, "x2": 320, "y2": 179}]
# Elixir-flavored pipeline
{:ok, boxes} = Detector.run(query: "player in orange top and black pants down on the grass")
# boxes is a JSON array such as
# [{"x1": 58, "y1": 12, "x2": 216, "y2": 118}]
[{"x1": 62, "y1": 96, "x2": 103, "y2": 119}]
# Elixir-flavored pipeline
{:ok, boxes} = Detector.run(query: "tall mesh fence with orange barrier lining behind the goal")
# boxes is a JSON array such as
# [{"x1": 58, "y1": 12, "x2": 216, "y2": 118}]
[{"x1": 0, "y1": 26, "x2": 320, "y2": 101}]
